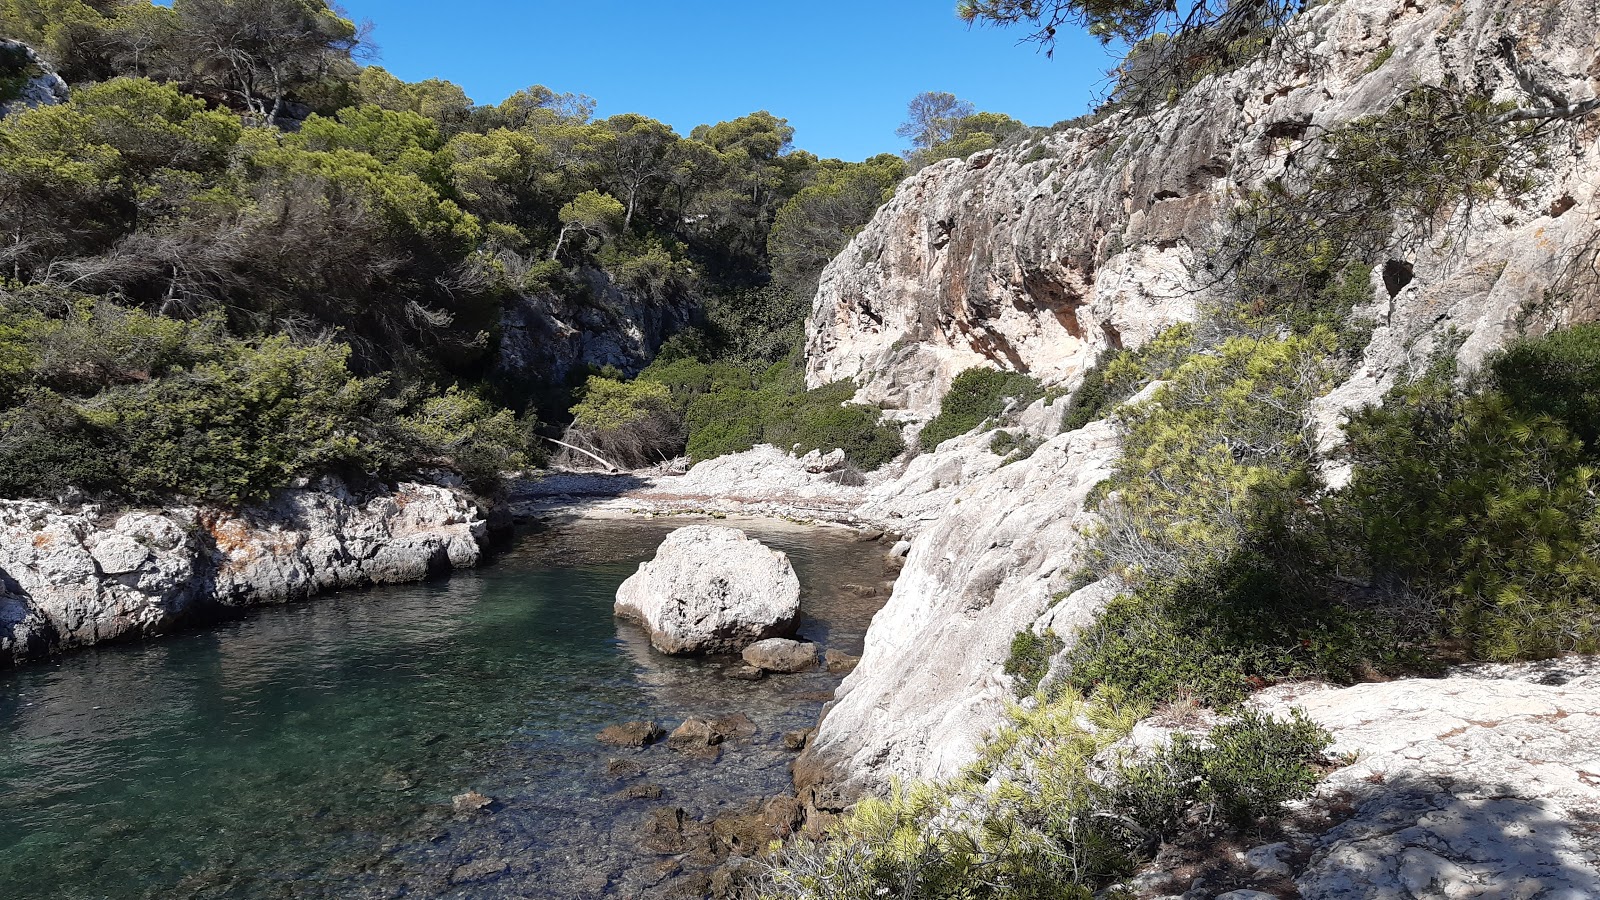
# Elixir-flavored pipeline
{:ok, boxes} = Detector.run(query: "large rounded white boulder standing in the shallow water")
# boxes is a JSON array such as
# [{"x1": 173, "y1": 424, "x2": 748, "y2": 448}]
[{"x1": 616, "y1": 525, "x2": 800, "y2": 653}]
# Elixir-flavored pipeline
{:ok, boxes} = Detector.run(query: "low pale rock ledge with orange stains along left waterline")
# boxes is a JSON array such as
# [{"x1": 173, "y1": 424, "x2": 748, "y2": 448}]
[{"x1": 0, "y1": 479, "x2": 486, "y2": 663}]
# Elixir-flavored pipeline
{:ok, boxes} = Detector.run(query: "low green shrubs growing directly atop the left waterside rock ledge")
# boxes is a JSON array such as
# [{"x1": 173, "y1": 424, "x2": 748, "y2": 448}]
[{"x1": 0, "y1": 291, "x2": 531, "y2": 504}]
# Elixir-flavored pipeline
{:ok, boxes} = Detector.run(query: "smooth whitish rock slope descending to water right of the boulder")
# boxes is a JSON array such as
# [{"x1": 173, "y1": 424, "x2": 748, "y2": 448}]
[{"x1": 795, "y1": 423, "x2": 1117, "y2": 794}]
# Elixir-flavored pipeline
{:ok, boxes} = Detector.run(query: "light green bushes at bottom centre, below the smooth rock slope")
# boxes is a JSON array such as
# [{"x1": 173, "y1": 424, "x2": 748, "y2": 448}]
[{"x1": 763, "y1": 697, "x2": 1330, "y2": 900}]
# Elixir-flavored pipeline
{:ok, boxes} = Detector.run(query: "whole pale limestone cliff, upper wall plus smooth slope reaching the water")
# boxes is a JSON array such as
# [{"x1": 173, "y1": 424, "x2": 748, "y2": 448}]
[{"x1": 797, "y1": 0, "x2": 1600, "y2": 807}]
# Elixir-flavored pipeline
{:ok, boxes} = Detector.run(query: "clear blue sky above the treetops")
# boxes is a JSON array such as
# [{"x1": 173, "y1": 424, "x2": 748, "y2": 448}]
[{"x1": 332, "y1": 0, "x2": 1110, "y2": 160}]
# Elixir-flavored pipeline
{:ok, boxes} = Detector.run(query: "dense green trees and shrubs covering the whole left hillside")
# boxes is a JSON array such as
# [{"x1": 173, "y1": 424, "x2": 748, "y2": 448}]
[{"x1": 0, "y1": 0, "x2": 928, "y2": 501}]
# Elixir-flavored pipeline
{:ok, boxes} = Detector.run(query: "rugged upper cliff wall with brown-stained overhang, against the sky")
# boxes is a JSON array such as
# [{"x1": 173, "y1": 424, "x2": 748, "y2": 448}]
[{"x1": 806, "y1": 0, "x2": 1600, "y2": 415}]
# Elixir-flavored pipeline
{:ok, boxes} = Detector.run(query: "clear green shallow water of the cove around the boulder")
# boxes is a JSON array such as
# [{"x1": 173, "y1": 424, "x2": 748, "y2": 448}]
[{"x1": 0, "y1": 522, "x2": 886, "y2": 900}]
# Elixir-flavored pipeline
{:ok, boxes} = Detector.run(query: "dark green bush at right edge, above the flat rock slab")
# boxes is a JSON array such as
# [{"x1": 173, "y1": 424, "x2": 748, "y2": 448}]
[{"x1": 1334, "y1": 344, "x2": 1600, "y2": 660}]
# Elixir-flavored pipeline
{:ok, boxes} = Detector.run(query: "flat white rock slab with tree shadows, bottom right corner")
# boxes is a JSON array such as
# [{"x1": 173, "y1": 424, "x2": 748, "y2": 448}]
[{"x1": 1256, "y1": 658, "x2": 1600, "y2": 900}]
